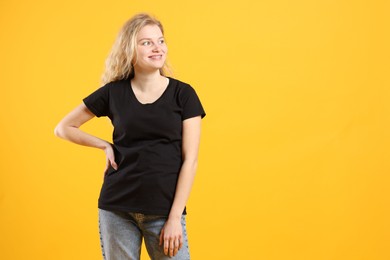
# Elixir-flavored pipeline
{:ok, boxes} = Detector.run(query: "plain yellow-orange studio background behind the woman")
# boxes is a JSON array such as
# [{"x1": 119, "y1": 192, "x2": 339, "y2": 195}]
[{"x1": 0, "y1": 0, "x2": 390, "y2": 260}]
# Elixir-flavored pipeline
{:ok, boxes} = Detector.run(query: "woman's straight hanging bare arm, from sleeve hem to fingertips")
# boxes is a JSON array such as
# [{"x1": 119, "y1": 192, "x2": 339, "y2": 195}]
[{"x1": 160, "y1": 116, "x2": 201, "y2": 256}]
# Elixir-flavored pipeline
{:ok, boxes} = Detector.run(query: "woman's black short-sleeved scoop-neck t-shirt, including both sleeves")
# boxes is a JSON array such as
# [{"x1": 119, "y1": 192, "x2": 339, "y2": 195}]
[{"x1": 83, "y1": 77, "x2": 206, "y2": 216}]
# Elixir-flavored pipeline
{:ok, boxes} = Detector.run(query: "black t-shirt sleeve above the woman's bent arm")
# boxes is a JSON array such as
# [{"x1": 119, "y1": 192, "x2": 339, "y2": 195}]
[{"x1": 83, "y1": 84, "x2": 110, "y2": 117}]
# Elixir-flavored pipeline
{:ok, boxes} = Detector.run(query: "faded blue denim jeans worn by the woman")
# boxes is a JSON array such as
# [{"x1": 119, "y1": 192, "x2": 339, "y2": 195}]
[{"x1": 98, "y1": 208, "x2": 190, "y2": 260}]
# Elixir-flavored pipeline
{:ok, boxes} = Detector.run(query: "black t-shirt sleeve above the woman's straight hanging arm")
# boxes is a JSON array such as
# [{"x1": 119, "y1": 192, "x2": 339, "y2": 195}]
[{"x1": 181, "y1": 85, "x2": 206, "y2": 120}]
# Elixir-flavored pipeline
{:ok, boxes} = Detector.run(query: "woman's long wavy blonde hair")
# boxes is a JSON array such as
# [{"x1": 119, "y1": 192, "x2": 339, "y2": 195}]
[{"x1": 101, "y1": 13, "x2": 172, "y2": 85}]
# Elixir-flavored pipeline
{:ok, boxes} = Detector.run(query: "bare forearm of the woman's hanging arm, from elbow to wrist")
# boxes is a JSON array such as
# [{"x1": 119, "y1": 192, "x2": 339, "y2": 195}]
[{"x1": 169, "y1": 161, "x2": 197, "y2": 219}]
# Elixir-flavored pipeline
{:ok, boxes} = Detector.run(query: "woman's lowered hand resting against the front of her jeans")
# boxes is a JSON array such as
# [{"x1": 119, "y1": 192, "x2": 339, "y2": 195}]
[{"x1": 159, "y1": 218, "x2": 183, "y2": 257}]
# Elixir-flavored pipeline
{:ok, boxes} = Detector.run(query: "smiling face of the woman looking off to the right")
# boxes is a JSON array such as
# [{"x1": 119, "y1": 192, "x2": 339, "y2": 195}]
[{"x1": 133, "y1": 25, "x2": 168, "y2": 71}]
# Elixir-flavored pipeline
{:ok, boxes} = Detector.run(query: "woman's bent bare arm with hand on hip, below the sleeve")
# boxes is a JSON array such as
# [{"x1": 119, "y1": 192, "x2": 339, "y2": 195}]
[{"x1": 54, "y1": 103, "x2": 118, "y2": 170}]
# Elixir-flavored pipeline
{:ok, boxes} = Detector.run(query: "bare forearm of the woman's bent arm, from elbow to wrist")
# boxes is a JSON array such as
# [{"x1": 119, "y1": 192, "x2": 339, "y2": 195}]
[{"x1": 55, "y1": 126, "x2": 110, "y2": 150}]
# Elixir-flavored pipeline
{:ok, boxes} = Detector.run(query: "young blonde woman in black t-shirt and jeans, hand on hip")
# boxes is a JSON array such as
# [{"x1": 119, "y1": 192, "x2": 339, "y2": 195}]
[{"x1": 55, "y1": 13, "x2": 206, "y2": 259}]
